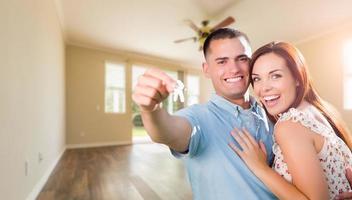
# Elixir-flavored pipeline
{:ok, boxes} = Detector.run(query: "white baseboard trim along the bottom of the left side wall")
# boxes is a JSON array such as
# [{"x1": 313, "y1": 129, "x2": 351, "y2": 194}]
[{"x1": 26, "y1": 147, "x2": 66, "y2": 200}]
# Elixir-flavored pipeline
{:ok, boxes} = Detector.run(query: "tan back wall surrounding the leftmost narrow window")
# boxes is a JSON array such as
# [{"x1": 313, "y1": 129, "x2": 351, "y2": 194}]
[{"x1": 66, "y1": 45, "x2": 208, "y2": 147}]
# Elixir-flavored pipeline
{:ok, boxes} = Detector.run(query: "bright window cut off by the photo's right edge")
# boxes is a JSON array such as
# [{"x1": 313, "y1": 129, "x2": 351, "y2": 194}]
[{"x1": 343, "y1": 40, "x2": 352, "y2": 109}]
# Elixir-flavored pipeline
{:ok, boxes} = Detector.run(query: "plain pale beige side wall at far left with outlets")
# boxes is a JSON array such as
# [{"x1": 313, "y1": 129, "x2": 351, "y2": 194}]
[{"x1": 0, "y1": 0, "x2": 65, "y2": 200}]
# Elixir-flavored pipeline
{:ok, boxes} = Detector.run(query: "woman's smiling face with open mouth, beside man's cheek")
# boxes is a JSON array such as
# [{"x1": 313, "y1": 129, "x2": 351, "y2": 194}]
[{"x1": 252, "y1": 53, "x2": 298, "y2": 116}]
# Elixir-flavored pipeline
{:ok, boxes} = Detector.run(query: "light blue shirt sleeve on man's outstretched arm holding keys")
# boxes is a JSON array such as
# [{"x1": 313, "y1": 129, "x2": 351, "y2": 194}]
[{"x1": 170, "y1": 105, "x2": 204, "y2": 158}]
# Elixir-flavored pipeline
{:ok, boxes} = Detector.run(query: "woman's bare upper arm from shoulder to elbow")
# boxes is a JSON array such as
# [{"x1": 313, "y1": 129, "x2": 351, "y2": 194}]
[{"x1": 274, "y1": 121, "x2": 329, "y2": 199}]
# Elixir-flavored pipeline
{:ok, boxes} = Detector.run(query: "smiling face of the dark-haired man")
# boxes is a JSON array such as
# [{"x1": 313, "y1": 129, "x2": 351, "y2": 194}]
[{"x1": 203, "y1": 37, "x2": 251, "y2": 101}]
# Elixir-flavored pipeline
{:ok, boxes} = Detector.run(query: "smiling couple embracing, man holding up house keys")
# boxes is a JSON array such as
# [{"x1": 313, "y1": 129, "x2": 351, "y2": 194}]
[{"x1": 133, "y1": 28, "x2": 352, "y2": 200}]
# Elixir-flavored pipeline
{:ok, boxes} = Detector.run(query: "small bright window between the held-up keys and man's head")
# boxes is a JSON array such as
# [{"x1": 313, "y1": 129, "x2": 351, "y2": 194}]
[{"x1": 186, "y1": 75, "x2": 200, "y2": 106}]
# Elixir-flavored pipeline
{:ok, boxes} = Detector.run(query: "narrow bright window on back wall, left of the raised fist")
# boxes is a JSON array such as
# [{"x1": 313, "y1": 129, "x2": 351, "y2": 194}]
[{"x1": 105, "y1": 62, "x2": 126, "y2": 113}]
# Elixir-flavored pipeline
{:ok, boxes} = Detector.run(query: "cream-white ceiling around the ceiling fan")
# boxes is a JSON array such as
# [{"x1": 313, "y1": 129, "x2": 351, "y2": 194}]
[{"x1": 55, "y1": 0, "x2": 352, "y2": 67}]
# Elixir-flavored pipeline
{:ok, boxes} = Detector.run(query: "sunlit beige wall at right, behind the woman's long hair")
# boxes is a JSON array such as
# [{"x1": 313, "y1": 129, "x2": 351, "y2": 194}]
[{"x1": 297, "y1": 25, "x2": 352, "y2": 130}]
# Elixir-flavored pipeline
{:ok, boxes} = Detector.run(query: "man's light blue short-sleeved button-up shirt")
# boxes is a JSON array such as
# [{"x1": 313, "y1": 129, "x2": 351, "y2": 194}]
[{"x1": 172, "y1": 95, "x2": 276, "y2": 200}]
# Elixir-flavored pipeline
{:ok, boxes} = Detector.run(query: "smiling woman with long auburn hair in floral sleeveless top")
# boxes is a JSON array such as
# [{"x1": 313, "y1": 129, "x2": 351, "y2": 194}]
[{"x1": 230, "y1": 42, "x2": 352, "y2": 200}]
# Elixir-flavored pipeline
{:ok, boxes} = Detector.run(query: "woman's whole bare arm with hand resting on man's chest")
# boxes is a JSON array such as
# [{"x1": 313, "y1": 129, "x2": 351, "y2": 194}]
[{"x1": 230, "y1": 121, "x2": 329, "y2": 200}]
